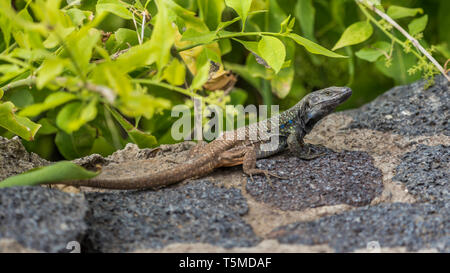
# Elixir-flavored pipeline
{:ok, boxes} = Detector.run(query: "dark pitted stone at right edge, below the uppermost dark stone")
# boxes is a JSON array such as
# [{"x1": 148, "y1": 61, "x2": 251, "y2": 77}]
[{"x1": 392, "y1": 144, "x2": 450, "y2": 202}]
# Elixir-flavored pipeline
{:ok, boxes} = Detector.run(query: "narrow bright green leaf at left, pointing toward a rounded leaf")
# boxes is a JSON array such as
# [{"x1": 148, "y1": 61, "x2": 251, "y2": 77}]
[{"x1": 19, "y1": 91, "x2": 77, "y2": 117}]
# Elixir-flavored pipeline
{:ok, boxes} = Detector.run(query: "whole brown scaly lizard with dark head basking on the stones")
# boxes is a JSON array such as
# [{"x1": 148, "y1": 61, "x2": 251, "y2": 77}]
[{"x1": 58, "y1": 87, "x2": 352, "y2": 190}]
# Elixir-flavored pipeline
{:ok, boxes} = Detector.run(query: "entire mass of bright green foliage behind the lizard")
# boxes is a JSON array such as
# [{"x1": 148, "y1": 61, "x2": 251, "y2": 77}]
[{"x1": 0, "y1": 0, "x2": 444, "y2": 160}]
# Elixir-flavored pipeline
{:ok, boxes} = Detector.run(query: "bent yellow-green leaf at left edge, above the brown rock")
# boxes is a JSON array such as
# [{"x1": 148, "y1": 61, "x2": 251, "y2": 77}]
[{"x1": 0, "y1": 101, "x2": 41, "y2": 141}]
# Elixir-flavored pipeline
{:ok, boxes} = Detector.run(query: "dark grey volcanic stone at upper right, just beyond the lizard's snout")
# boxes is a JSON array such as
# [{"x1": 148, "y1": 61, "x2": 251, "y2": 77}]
[{"x1": 347, "y1": 75, "x2": 450, "y2": 136}]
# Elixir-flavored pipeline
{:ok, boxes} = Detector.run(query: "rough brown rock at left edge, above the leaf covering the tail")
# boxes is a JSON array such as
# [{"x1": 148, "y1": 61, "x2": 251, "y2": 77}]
[{"x1": 0, "y1": 136, "x2": 48, "y2": 181}]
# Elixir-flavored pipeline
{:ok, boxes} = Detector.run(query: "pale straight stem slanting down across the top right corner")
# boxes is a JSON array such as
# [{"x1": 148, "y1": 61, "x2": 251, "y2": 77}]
[{"x1": 356, "y1": 0, "x2": 450, "y2": 81}]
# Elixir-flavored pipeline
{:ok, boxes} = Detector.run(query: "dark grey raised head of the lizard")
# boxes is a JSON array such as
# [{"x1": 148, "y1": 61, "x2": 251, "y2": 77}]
[{"x1": 299, "y1": 87, "x2": 352, "y2": 133}]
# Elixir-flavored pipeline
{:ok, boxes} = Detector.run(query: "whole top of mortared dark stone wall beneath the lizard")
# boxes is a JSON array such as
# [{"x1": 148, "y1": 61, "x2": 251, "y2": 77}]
[{"x1": 0, "y1": 76, "x2": 450, "y2": 252}]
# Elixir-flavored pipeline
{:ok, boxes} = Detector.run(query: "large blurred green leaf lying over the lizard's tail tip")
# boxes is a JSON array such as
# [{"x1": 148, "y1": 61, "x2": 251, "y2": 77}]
[{"x1": 0, "y1": 161, "x2": 99, "y2": 188}]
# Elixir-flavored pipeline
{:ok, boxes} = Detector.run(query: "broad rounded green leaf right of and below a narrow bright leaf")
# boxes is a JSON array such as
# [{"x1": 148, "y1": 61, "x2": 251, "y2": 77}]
[{"x1": 56, "y1": 100, "x2": 97, "y2": 134}]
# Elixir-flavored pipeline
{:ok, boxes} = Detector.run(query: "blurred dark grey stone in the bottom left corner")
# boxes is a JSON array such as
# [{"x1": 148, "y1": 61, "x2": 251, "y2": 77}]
[{"x1": 0, "y1": 187, "x2": 88, "y2": 252}]
